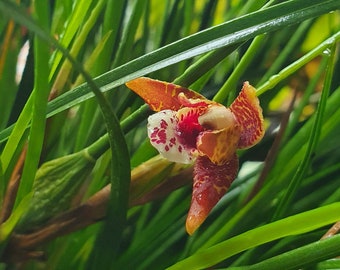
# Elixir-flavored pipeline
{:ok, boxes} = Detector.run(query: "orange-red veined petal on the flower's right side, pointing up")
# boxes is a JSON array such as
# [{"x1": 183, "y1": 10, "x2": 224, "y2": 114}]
[{"x1": 230, "y1": 82, "x2": 264, "y2": 148}]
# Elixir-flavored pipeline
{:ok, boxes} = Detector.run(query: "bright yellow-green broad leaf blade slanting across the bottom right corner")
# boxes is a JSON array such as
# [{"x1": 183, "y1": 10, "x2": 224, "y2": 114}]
[{"x1": 168, "y1": 203, "x2": 340, "y2": 270}]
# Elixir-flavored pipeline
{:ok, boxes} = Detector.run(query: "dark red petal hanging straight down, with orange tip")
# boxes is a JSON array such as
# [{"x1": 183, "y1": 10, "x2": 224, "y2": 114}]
[{"x1": 186, "y1": 154, "x2": 238, "y2": 235}]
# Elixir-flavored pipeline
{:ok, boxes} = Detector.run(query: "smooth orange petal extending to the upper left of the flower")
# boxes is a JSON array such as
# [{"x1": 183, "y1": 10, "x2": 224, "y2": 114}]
[{"x1": 126, "y1": 77, "x2": 205, "y2": 112}]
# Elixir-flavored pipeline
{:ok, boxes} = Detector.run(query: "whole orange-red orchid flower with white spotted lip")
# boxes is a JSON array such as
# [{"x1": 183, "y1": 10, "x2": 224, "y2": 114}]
[{"x1": 126, "y1": 77, "x2": 264, "y2": 235}]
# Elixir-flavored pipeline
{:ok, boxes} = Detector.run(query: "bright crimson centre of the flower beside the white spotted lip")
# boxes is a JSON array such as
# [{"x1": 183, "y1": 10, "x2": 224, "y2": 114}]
[{"x1": 176, "y1": 108, "x2": 204, "y2": 148}]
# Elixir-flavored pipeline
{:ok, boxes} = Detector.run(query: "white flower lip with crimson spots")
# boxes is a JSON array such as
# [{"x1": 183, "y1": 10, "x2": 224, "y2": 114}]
[{"x1": 148, "y1": 110, "x2": 196, "y2": 164}]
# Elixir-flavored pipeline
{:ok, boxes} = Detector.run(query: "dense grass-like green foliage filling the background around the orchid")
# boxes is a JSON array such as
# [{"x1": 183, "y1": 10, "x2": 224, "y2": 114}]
[{"x1": 0, "y1": 0, "x2": 340, "y2": 269}]
